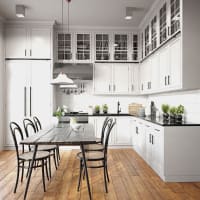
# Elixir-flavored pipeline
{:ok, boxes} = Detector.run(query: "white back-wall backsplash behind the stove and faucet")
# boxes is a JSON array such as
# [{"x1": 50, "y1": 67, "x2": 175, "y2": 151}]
[{"x1": 56, "y1": 81, "x2": 146, "y2": 113}]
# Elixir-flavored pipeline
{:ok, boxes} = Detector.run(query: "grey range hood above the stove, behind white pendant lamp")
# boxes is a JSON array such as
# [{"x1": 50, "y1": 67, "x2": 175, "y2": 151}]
[{"x1": 53, "y1": 63, "x2": 93, "y2": 80}]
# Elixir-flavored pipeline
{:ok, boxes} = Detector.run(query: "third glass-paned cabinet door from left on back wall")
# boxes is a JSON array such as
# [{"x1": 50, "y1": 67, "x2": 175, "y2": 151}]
[{"x1": 95, "y1": 33, "x2": 110, "y2": 61}]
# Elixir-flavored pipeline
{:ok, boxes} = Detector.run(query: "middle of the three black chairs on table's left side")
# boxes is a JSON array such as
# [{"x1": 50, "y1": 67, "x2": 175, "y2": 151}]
[{"x1": 23, "y1": 118, "x2": 57, "y2": 178}]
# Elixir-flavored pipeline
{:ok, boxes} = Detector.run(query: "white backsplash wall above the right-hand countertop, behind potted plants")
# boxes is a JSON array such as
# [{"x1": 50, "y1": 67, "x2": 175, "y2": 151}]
[{"x1": 147, "y1": 90, "x2": 200, "y2": 123}]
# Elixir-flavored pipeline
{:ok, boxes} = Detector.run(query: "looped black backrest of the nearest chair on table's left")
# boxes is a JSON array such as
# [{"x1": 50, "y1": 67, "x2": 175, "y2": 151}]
[{"x1": 10, "y1": 122, "x2": 24, "y2": 158}]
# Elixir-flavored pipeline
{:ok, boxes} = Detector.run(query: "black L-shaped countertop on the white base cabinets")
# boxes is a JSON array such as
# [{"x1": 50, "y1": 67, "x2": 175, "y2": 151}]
[{"x1": 62, "y1": 113, "x2": 200, "y2": 126}]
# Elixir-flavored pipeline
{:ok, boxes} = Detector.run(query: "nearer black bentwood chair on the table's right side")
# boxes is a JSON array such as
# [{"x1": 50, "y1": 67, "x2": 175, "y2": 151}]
[{"x1": 77, "y1": 120, "x2": 116, "y2": 193}]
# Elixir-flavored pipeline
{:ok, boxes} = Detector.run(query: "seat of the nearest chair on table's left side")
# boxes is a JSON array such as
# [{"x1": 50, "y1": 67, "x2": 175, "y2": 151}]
[{"x1": 19, "y1": 151, "x2": 49, "y2": 161}]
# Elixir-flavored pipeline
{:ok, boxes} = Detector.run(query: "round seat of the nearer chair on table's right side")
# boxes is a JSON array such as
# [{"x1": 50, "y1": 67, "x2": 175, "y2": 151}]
[{"x1": 77, "y1": 151, "x2": 104, "y2": 161}]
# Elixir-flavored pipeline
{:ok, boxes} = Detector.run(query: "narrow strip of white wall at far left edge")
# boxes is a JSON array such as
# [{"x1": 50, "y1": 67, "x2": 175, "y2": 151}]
[{"x1": 0, "y1": 18, "x2": 4, "y2": 150}]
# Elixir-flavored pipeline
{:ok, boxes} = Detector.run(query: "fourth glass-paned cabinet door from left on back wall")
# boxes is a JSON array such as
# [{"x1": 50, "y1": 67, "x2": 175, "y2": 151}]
[{"x1": 114, "y1": 34, "x2": 128, "y2": 60}]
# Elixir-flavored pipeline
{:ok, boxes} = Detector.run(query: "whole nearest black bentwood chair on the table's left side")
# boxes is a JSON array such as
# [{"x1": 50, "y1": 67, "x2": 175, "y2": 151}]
[{"x1": 10, "y1": 122, "x2": 50, "y2": 193}]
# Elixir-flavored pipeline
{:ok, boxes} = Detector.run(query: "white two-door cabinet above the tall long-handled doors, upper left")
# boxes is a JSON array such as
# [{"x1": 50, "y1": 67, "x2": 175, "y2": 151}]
[{"x1": 5, "y1": 26, "x2": 52, "y2": 59}]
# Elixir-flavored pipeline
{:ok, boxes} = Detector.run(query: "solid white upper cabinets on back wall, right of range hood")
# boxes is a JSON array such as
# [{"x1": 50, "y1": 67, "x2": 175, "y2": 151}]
[{"x1": 93, "y1": 63, "x2": 139, "y2": 95}]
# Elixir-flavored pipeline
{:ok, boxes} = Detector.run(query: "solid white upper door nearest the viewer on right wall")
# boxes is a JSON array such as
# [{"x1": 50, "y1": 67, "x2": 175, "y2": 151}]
[{"x1": 168, "y1": 38, "x2": 181, "y2": 87}]
